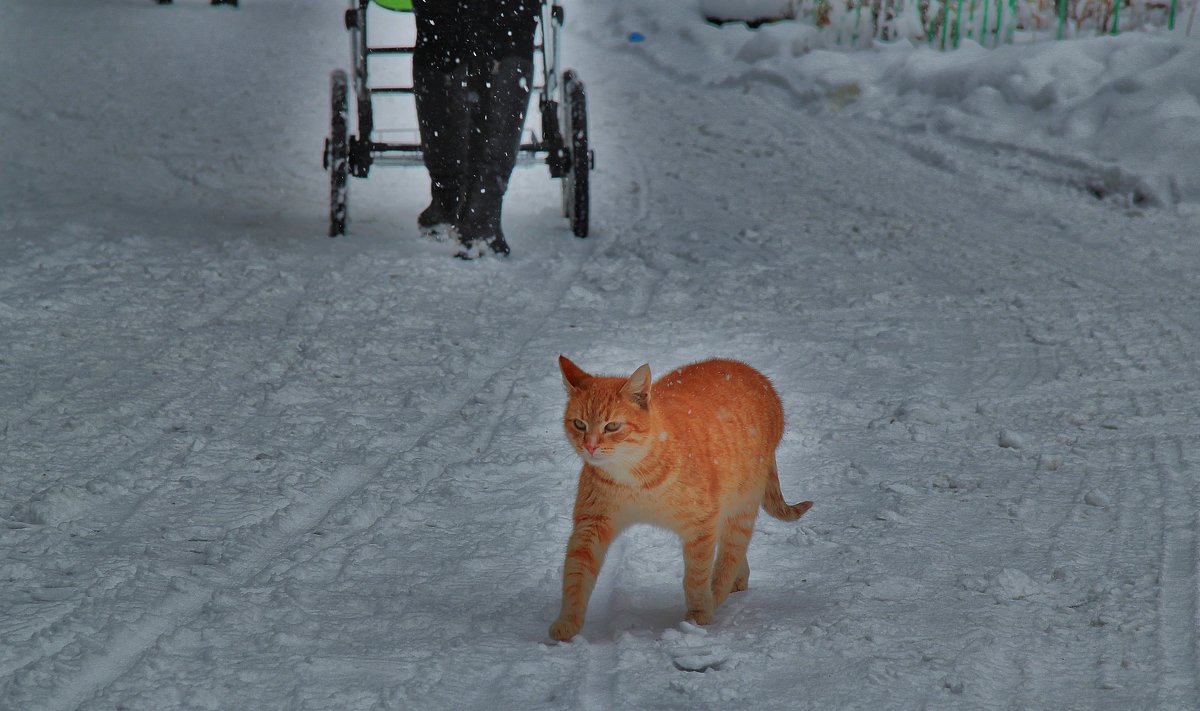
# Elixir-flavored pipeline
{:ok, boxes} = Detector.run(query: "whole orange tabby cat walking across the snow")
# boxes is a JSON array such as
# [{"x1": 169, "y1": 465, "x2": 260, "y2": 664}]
[{"x1": 550, "y1": 356, "x2": 812, "y2": 640}]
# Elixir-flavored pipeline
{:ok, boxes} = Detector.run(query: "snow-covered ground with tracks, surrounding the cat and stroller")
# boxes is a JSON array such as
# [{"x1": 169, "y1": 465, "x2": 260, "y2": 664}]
[{"x1": 0, "y1": 0, "x2": 1200, "y2": 711}]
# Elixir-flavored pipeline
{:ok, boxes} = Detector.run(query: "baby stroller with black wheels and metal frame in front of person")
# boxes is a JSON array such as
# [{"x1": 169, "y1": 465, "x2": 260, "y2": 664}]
[{"x1": 323, "y1": 0, "x2": 595, "y2": 237}]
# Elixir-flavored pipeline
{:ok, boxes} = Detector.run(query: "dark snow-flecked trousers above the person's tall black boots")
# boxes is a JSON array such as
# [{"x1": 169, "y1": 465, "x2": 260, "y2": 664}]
[{"x1": 413, "y1": 0, "x2": 541, "y2": 72}]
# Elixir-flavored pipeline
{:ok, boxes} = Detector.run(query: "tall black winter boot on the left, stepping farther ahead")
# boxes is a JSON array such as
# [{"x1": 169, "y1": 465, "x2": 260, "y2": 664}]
[{"x1": 413, "y1": 64, "x2": 470, "y2": 240}]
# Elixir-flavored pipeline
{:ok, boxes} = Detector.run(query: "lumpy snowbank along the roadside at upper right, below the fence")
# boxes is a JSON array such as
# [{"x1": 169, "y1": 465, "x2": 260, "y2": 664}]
[{"x1": 583, "y1": 0, "x2": 1200, "y2": 205}]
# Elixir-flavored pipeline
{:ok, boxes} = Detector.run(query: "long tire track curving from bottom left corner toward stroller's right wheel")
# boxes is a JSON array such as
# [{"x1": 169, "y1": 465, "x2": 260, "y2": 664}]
[{"x1": 28, "y1": 224, "x2": 604, "y2": 710}]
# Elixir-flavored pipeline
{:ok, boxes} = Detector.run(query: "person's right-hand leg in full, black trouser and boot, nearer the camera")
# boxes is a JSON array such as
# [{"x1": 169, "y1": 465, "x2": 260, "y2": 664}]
[{"x1": 458, "y1": 0, "x2": 540, "y2": 256}]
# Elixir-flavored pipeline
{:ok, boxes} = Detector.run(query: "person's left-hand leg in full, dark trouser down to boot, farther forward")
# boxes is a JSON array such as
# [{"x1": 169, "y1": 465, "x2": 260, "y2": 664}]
[{"x1": 413, "y1": 0, "x2": 469, "y2": 238}]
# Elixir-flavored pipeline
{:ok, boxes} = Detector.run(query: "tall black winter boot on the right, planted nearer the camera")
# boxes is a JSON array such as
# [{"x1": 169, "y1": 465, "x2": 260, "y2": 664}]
[{"x1": 457, "y1": 56, "x2": 533, "y2": 259}]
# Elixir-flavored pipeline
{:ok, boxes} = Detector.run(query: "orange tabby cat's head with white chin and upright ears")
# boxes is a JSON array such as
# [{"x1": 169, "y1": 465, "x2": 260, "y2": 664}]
[{"x1": 558, "y1": 356, "x2": 653, "y2": 474}]
